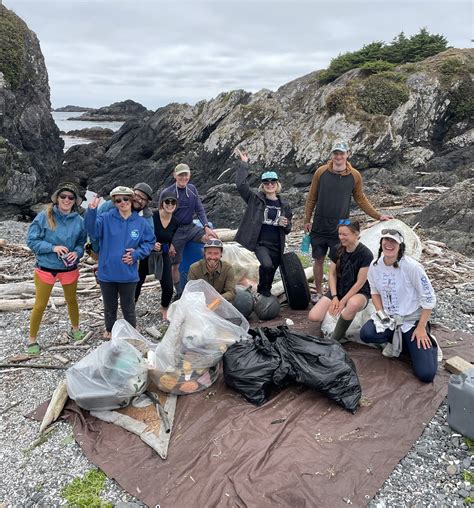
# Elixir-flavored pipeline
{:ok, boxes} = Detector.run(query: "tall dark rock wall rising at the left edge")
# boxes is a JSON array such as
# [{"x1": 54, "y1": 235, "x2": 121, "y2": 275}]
[{"x1": 0, "y1": 4, "x2": 64, "y2": 216}]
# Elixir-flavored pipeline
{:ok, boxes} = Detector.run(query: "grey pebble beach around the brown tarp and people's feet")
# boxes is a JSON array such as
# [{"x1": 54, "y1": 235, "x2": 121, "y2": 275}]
[{"x1": 0, "y1": 221, "x2": 474, "y2": 508}]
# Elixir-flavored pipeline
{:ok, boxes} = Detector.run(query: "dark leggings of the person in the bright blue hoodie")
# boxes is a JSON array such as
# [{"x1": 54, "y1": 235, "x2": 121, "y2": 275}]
[{"x1": 99, "y1": 281, "x2": 137, "y2": 332}]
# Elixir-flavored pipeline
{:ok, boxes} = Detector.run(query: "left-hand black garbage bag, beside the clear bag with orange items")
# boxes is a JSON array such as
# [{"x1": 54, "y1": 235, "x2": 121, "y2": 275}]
[{"x1": 223, "y1": 330, "x2": 281, "y2": 406}]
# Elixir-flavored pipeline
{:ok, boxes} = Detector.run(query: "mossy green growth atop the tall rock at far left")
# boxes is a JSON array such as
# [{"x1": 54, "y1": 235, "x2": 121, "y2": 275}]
[{"x1": 0, "y1": 5, "x2": 27, "y2": 90}]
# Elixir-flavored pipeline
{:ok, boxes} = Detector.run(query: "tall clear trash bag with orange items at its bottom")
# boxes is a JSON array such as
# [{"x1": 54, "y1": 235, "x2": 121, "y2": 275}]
[{"x1": 149, "y1": 280, "x2": 249, "y2": 395}]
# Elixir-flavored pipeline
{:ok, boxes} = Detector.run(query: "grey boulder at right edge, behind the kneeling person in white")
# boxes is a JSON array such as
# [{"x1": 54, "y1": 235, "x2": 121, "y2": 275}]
[{"x1": 416, "y1": 180, "x2": 474, "y2": 256}]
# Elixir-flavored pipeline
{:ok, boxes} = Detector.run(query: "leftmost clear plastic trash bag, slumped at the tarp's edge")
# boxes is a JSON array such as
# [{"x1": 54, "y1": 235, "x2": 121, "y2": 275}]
[{"x1": 66, "y1": 319, "x2": 151, "y2": 411}]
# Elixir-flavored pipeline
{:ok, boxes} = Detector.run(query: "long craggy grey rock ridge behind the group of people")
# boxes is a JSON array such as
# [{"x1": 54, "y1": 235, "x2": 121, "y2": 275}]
[{"x1": 65, "y1": 49, "x2": 474, "y2": 249}]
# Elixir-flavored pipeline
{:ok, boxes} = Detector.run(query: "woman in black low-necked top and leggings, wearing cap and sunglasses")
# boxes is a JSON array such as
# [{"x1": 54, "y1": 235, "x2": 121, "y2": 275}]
[{"x1": 145, "y1": 192, "x2": 179, "y2": 321}]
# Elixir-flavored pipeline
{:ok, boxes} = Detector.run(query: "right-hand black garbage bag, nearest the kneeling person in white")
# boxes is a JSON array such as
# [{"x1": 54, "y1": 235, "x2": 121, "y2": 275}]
[{"x1": 261, "y1": 326, "x2": 362, "y2": 412}]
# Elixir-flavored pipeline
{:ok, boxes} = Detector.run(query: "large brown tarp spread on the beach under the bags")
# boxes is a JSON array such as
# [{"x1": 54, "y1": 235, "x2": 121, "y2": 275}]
[{"x1": 31, "y1": 313, "x2": 474, "y2": 508}]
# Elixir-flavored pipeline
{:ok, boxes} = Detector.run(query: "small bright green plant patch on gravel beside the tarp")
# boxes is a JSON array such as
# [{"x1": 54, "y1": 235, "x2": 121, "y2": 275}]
[{"x1": 61, "y1": 469, "x2": 112, "y2": 508}]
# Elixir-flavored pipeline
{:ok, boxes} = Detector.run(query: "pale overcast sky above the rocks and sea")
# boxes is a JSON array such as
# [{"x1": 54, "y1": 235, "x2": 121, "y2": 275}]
[{"x1": 4, "y1": 0, "x2": 474, "y2": 109}]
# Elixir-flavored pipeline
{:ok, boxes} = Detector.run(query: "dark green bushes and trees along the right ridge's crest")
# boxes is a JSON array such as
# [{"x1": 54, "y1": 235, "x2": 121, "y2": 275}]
[{"x1": 319, "y1": 28, "x2": 448, "y2": 83}]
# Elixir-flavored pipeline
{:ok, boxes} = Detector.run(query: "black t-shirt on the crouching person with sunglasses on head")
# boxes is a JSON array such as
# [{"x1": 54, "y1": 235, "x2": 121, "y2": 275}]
[{"x1": 329, "y1": 243, "x2": 374, "y2": 299}]
